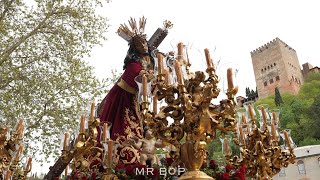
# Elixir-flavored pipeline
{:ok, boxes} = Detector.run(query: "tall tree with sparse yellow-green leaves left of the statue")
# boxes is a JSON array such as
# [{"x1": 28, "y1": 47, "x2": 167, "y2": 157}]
[{"x1": 0, "y1": 0, "x2": 110, "y2": 160}]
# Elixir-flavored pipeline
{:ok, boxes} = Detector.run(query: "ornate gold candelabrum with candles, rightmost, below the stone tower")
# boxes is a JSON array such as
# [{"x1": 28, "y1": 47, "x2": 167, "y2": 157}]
[{"x1": 229, "y1": 102, "x2": 295, "y2": 180}]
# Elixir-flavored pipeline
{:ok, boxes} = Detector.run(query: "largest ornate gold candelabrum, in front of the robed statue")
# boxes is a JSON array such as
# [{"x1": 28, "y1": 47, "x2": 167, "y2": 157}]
[{"x1": 136, "y1": 43, "x2": 238, "y2": 179}]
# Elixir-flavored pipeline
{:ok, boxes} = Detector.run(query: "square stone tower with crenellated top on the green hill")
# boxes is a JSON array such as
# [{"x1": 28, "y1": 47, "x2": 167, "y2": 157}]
[{"x1": 251, "y1": 38, "x2": 303, "y2": 98}]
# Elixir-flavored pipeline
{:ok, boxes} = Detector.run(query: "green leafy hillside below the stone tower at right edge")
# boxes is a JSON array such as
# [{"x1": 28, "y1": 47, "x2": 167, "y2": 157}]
[{"x1": 255, "y1": 73, "x2": 320, "y2": 146}]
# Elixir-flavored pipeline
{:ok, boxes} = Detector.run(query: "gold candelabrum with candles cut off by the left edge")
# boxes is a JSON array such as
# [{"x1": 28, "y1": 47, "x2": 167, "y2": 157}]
[{"x1": 0, "y1": 119, "x2": 32, "y2": 180}]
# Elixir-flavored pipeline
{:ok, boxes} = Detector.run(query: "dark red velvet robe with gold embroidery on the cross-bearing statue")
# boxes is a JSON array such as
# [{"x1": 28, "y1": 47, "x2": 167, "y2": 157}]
[{"x1": 100, "y1": 62, "x2": 142, "y2": 143}]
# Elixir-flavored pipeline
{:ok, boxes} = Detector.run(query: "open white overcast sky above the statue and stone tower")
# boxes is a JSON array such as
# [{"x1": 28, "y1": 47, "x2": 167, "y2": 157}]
[{"x1": 89, "y1": 0, "x2": 320, "y2": 96}]
